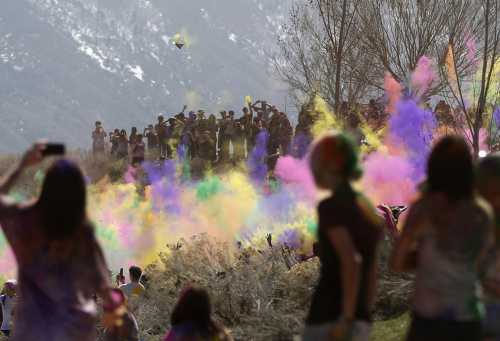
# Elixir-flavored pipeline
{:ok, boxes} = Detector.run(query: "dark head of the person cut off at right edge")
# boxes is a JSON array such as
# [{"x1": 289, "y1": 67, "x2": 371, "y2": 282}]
[{"x1": 476, "y1": 153, "x2": 500, "y2": 219}]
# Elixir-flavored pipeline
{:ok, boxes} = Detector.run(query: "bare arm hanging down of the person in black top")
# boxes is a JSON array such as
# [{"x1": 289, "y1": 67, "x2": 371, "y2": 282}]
[{"x1": 328, "y1": 227, "x2": 363, "y2": 322}]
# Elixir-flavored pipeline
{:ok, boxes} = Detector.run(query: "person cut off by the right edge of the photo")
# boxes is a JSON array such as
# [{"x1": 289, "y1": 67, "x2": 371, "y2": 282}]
[{"x1": 476, "y1": 153, "x2": 500, "y2": 340}]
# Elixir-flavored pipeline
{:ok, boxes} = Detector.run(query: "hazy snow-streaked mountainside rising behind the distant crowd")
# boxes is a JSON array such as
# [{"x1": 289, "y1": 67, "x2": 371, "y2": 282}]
[{"x1": 0, "y1": 0, "x2": 289, "y2": 152}]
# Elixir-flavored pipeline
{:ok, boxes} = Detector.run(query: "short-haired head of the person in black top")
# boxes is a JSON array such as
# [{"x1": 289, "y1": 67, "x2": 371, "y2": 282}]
[{"x1": 310, "y1": 133, "x2": 362, "y2": 190}]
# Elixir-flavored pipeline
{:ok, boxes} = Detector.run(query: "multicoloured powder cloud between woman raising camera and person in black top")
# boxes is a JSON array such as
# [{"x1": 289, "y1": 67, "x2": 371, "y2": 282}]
[{"x1": 84, "y1": 159, "x2": 315, "y2": 268}]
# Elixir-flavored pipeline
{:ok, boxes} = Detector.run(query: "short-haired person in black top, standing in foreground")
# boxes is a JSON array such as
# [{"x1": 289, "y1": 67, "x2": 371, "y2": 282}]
[{"x1": 303, "y1": 134, "x2": 382, "y2": 341}]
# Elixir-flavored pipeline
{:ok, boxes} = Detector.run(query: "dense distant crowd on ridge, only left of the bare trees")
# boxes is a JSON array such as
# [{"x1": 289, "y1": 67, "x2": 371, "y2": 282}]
[{"x1": 92, "y1": 101, "x2": 312, "y2": 168}]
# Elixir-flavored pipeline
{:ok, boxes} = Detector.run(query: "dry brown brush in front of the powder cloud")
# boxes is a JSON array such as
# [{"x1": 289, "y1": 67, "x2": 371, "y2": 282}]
[{"x1": 112, "y1": 235, "x2": 411, "y2": 341}]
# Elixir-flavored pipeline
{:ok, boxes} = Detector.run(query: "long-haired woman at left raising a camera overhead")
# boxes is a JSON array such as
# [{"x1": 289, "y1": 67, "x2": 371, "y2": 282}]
[{"x1": 0, "y1": 144, "x2": 119, "y2": 341}]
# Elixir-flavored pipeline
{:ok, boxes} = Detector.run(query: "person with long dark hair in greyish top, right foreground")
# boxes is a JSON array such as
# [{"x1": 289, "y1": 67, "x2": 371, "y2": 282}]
[{"x1": 390, "y1": 136, "x2": 494, "y2": 341}]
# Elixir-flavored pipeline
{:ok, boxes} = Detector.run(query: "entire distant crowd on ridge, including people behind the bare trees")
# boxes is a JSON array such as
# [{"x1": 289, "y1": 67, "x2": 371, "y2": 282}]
[{"x1": 92, "y1": 99, "x2": 426, "y2": 171}]
